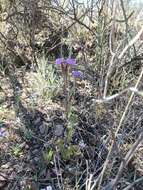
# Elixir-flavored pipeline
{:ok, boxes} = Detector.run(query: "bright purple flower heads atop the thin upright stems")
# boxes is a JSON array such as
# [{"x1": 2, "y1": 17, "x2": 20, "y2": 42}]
[{"x1": 56, "y1": 58, "x2": 82, "y2": 78}]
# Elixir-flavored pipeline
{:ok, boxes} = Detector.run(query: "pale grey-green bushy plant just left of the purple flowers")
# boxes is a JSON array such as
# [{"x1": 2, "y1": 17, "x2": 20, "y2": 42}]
[{"x1": 30, "y1": 56, "x2": 60, "y2": 100}]
